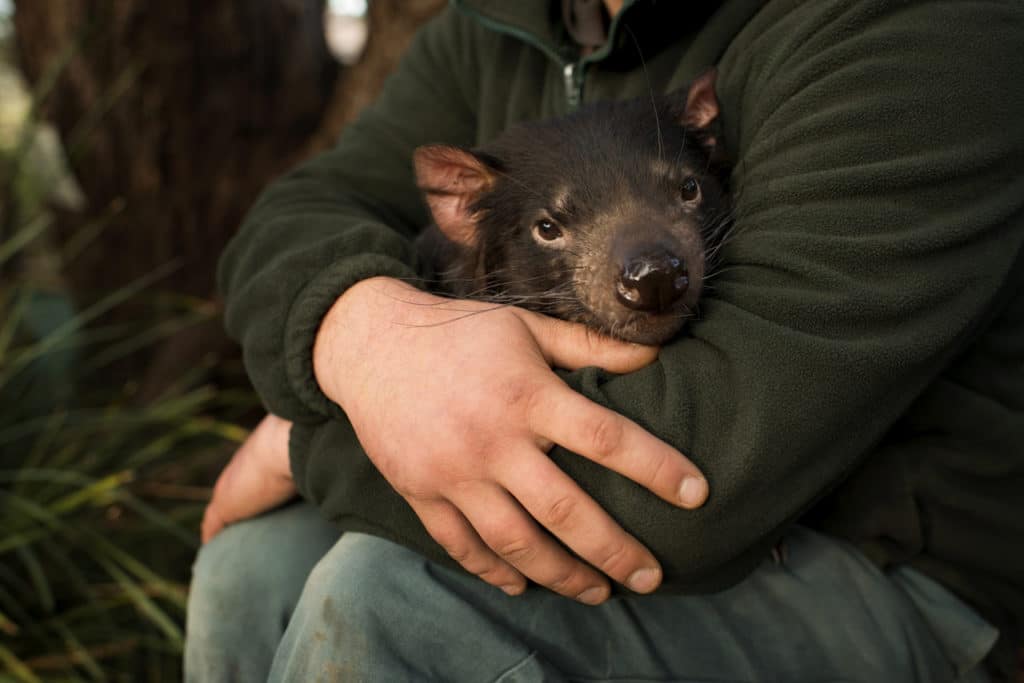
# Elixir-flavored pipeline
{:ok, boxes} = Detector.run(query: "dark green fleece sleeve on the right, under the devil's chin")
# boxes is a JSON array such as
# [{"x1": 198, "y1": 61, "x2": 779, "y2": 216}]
[{"x1": 553, "y1": 2, "x2": 1024, "y2": 591}]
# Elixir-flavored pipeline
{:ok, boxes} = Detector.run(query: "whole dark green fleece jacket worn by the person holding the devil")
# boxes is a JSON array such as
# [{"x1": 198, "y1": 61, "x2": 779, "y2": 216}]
[{"x1": 220, "y1": 0, "x2": 1024, "y2": 663}]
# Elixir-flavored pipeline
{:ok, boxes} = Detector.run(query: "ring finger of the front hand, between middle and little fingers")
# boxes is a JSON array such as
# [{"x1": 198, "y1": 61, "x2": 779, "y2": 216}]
[{"x1": 452, "y1": 485, "x2": 610, "y2": 604}]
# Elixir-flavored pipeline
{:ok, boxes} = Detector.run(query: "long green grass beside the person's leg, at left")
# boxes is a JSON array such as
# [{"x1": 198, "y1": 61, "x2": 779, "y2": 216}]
[{"x1": 0, "y1": 15, "x2": 255, "y2": 683}]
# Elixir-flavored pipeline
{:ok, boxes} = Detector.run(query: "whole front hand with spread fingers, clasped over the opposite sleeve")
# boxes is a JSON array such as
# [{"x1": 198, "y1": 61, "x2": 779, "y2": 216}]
[{"x1": 313, "y1": 278, "x2": 708, "y2": 604}]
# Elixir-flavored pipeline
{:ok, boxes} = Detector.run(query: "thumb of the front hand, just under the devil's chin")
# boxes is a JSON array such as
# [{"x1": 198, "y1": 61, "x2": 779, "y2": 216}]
[{"x1": 523, "y1": 311, "x2": 658, "y2": 374}]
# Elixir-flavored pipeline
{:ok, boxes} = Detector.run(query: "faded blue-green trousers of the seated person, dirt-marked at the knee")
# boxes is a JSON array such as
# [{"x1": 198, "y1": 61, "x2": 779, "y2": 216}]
[{"x1": 185, "y1": 504, "x2": 996, "y2": 683}]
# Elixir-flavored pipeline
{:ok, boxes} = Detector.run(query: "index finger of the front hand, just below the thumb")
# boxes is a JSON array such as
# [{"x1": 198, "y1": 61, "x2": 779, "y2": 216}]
[{"x1": 528, "y1": 382, "x2": 708, "y2": 508}]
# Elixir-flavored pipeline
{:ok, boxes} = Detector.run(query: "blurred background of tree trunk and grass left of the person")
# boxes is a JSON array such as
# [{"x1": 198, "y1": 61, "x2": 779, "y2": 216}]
[{"x1": 0, "y1": 0, "x2": 443, "y2": 683}]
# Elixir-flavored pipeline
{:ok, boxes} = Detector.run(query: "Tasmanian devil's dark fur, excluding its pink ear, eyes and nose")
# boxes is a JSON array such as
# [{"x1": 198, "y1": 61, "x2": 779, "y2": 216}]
[{"x1": 411, "y1": 82, "x2": 730, "y2": 343}]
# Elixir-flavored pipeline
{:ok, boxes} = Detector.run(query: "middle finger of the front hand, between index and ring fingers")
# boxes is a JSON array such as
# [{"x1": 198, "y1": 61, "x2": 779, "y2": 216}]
[{"x1": 499, "y1": 448, "x2": 662, "y2": 593}]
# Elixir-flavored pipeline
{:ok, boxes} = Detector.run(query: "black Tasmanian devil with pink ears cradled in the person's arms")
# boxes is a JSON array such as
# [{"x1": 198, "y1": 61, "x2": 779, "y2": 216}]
[{"x1": 414, "y1": 71, "x2": 730, "y2": 344}]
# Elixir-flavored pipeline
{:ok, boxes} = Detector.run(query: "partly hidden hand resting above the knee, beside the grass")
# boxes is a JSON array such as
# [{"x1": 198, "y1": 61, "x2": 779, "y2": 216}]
[{"x1": 201, "y1": 415, "x2": 296, "y2": 543}]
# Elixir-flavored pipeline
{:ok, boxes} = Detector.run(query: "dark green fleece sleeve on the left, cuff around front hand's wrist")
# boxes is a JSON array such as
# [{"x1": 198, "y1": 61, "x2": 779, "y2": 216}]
[{"x1": 218, "y1": 11, "x2": 476, "y2": 422}]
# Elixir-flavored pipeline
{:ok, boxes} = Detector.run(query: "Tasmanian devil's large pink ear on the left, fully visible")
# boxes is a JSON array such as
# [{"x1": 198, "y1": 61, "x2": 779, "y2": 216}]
[{"x1": 413, "y1": 144, "x2": 495, "y2": 247}]
